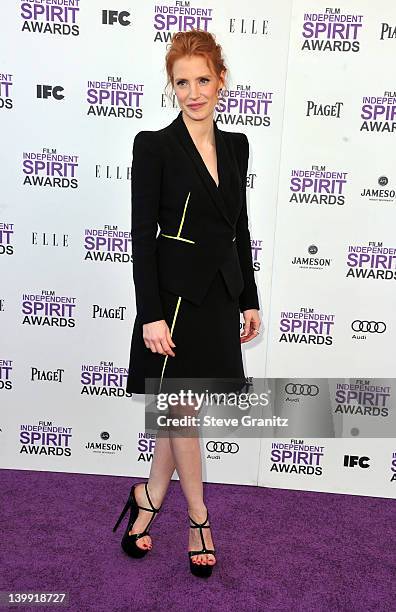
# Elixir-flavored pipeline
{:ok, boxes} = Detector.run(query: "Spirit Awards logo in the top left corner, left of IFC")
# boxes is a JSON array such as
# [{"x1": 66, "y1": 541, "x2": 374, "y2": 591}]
[{"x1": 21, "y1": 0, "x2": 80, "y2": 36}]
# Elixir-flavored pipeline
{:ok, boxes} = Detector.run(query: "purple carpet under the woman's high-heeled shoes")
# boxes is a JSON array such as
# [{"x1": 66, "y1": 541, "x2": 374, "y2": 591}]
[{"x1": 0, "y1": 470, "x2": 396, "y2": 612}]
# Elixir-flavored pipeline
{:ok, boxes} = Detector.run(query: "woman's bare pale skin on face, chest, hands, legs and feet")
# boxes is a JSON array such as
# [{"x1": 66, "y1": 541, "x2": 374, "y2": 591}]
[{"x1": 129, "y1": 56, "x2": 261, "y2": 565}]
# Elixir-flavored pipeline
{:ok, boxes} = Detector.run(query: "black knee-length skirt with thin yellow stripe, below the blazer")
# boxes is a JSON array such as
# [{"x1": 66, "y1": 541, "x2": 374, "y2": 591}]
[{"x1": 126, "y1": 269, "x2": 246, "y2": 394}]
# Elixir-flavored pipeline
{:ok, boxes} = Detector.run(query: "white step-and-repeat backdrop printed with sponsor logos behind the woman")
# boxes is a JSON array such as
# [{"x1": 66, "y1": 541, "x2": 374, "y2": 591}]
[{"x1": 0, "y1": 0, "x2": 396, "y2": 497}]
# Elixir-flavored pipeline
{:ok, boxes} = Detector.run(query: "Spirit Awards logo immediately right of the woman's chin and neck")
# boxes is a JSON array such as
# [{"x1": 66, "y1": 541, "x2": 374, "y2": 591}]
[{"x1": 216, "y1": 84, "x2": 273, "y2": 127}]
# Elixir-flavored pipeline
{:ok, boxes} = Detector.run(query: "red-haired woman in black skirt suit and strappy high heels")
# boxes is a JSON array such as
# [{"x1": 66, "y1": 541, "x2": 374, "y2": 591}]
[{"x1": 114, "y1": 30, "x2": 260, "y2": 576}]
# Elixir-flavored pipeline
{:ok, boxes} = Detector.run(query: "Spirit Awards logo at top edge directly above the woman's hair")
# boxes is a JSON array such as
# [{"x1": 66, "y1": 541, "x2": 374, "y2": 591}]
[{"x1": 153, "y1": 2, "x2": 213, "y2": 42}]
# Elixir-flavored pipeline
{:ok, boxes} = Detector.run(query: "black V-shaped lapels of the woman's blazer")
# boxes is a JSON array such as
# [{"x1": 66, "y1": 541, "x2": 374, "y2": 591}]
[{"x1": 171, "y1": 111, "x2": 235, "y2": 225}]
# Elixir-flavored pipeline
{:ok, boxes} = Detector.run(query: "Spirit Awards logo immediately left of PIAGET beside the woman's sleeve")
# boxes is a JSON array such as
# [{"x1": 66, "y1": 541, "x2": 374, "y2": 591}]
[{"x1": 22, "y1": 290, "x2": 76, "y2": 327}]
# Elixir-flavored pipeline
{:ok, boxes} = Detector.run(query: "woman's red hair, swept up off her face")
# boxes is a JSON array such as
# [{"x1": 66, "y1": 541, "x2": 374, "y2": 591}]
[{"x1": 165, "y1": 29, "x2": 227, "y2": 97}]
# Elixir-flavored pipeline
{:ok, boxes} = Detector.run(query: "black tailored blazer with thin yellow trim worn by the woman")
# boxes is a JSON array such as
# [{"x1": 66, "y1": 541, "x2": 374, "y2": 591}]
[{"x1": 131, "y1": 111, "x2": 259, "y2": 324}]
